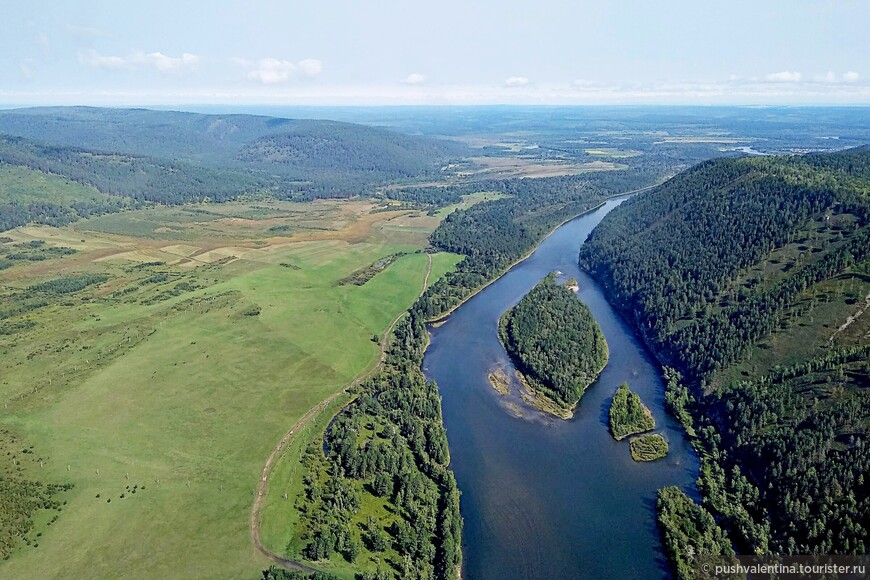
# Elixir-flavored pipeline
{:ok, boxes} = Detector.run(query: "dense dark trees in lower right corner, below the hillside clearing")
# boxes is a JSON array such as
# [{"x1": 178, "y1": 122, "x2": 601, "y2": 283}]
[{"x1": 712, "y1": 344, "x2": 870, "y2": 554}]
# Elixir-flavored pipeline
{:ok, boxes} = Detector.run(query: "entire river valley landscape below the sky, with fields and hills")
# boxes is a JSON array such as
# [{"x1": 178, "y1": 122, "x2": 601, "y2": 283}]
[{"x1": 0, "y1": 107, "x2": 870, "y2": 578}]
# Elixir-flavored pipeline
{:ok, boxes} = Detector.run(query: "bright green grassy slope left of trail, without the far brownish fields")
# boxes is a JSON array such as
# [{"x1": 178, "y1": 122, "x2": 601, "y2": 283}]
[{"x1": 0, "y1": 202, "x2": 464, "y2": 577}]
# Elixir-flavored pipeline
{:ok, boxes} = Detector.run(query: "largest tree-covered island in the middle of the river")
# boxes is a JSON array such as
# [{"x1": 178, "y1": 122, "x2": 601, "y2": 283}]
[{"x1": 499, "y1": 274, "x2": 608, "y2": 419}]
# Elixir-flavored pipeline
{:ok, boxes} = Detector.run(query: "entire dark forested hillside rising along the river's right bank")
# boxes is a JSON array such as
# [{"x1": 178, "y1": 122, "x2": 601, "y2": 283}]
[{"x1": 580, "y1": 148, "x2": 870, "y2": 554}]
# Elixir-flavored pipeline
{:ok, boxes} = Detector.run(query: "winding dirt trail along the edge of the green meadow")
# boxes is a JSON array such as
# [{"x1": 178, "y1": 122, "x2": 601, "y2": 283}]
[{"x1": 251, "y1": 253, "x2": 432, "y2": 573}]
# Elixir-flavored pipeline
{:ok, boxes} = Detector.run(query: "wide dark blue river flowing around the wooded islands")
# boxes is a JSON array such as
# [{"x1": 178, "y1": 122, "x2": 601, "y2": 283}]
[{"x1": 423, "y1": 198, "x2": 698, "y2": 580}]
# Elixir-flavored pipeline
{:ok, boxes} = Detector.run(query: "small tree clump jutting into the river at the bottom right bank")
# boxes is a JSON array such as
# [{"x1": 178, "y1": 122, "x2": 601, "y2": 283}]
[{"x1": 656, "y1": 486, "x2": 734, "y2": 580}]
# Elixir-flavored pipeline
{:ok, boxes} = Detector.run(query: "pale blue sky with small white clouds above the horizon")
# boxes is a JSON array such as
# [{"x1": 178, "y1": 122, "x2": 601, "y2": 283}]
[{"x1": 0, "y1": 0, "x2": 870, "y2": 106}]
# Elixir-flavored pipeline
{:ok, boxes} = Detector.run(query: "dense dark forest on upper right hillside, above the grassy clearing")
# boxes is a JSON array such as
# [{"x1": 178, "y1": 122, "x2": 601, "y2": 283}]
[{"x1": 580, "y1": 149, "x2": 870, "y2": 379}]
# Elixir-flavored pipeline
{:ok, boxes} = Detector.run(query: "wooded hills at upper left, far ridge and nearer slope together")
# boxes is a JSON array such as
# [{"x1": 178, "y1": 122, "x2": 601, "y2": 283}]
[{"x1": 0, "y1": 107, "x2": 467, "y2": 208}]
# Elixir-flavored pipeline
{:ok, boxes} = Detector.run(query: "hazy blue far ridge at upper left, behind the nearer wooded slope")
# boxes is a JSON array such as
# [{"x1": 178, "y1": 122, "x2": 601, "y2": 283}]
[{"x1": 0, "y1": 107, "x2": 466, "y2": 196}]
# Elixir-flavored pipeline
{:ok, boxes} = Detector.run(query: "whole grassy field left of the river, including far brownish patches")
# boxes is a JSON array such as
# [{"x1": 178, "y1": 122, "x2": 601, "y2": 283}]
[{"x1": 0, "y1": 201, "x2": 457, "y2": 578}]
